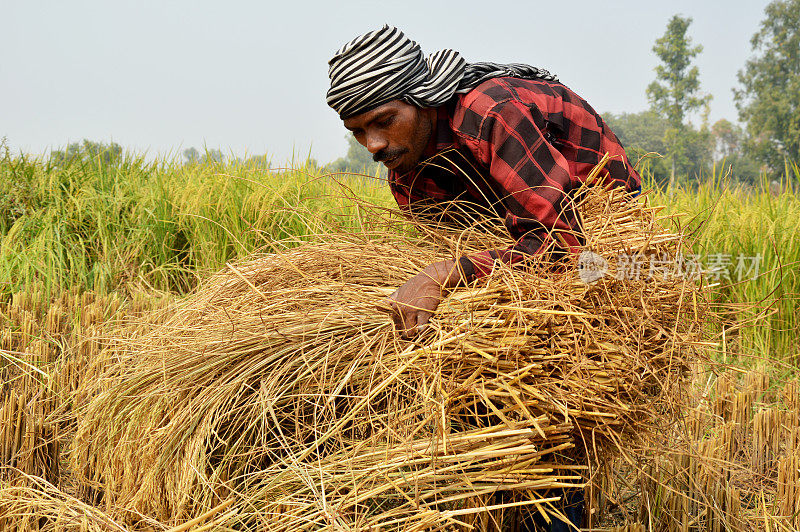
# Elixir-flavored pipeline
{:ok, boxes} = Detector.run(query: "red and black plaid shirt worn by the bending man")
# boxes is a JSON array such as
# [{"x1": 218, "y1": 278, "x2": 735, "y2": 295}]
[{"x1": 389, "y1": 78, "x2": 641, "y2": 278}]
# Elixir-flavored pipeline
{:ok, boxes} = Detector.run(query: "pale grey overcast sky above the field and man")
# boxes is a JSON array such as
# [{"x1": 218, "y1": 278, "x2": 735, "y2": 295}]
[{"x1": 0, "y1": 0, "x2": 769, "y2": 164}]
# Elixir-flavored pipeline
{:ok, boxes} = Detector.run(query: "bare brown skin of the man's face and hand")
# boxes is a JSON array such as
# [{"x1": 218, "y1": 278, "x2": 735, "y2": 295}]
[{"x1": 344, "y1": 100, "x2": 462, "y2": 339}]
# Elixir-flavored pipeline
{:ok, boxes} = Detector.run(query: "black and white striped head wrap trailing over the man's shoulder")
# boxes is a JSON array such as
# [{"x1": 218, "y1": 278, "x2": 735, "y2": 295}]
[{"x1": 328, "y1": 25, "x2": 558, "y2": 120}]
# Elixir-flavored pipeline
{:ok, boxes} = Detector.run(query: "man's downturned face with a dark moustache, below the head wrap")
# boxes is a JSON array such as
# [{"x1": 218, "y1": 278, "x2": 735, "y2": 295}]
[{"x1": 344, "y1": 100, "x2": 436, "y2": 173}]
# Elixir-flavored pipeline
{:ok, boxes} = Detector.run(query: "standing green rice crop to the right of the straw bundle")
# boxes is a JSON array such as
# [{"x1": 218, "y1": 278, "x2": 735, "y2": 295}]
[{"x1": 650, "y1": 165, "x2": 800, "y2": 363}]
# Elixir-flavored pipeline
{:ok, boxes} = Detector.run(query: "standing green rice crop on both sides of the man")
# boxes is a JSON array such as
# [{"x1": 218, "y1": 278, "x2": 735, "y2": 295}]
[{"x1": 0, "y1": 148, "x2": 800, "y2": 362}]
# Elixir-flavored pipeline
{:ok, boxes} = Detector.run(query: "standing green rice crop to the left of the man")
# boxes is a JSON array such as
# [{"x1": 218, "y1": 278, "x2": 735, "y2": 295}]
[{"x1": 0, "y1": 153, "x2": 389, "y2": 294}]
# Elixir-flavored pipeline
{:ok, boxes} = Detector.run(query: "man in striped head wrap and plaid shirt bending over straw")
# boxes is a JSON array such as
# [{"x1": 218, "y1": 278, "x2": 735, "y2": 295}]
[{"x1": 327, "y1": 25, "x2": 641, "y2": 338}]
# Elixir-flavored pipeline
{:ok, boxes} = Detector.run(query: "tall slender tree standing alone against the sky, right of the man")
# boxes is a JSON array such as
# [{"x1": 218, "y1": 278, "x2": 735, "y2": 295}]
[{"x1": 647, "y1": 15, "x2": 711, "y2": 186}]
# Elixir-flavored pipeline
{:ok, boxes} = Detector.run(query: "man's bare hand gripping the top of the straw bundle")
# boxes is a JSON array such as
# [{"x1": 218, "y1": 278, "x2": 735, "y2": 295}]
[{"x1": 389, "y1": 260, "x2": 461, "y2": 339}]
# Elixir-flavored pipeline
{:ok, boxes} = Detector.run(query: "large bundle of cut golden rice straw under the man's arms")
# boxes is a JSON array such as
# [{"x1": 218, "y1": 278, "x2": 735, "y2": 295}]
[{"x1": 61, "y1": 178, "x2": 701, "y2": 530}]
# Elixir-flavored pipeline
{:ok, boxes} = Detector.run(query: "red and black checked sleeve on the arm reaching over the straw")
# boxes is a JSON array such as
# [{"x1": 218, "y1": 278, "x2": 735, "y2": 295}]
[{"x1": 461, "y1": 99, "x2": 579, "y2": 277}]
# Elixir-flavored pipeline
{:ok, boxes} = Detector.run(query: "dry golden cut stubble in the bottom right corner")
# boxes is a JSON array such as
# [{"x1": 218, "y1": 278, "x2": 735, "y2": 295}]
[{"x1": 632, "y1": 368, "x2": 800, "y2": 532}]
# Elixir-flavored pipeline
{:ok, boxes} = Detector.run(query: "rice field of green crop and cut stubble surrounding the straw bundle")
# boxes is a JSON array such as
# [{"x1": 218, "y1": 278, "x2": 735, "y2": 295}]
[{"x1": 0, "y1": 152, "x2": 800, "y2": 531}]
